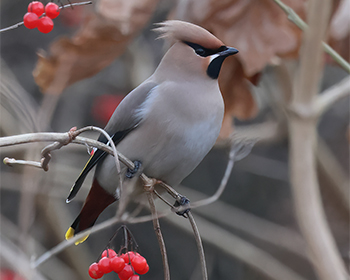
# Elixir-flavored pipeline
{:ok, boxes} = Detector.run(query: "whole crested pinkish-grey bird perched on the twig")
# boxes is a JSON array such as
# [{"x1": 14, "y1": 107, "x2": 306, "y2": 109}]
[{"x1": 65, "y1": 20, "x2": 238, "y2": 244}]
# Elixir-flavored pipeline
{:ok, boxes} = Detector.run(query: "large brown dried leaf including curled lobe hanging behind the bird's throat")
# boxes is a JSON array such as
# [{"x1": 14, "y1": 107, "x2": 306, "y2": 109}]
[{"x1": 182, "y1": 0, "x2": 305, "y2": 137}]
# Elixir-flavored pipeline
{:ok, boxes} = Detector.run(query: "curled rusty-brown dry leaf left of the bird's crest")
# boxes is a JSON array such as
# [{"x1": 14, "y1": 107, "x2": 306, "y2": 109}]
[{"x1": 33, "y1": 0, "x2": 159, "y2": 94}]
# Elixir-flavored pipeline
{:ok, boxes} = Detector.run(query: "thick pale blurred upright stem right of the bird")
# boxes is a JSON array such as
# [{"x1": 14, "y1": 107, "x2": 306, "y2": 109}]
[{"x1": 288, "y1": 0, "x2": 348, "y2": 280}]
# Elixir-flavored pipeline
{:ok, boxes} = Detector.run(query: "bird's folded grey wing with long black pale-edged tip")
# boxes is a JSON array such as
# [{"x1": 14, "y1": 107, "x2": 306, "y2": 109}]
[{"x1": 66, "y1": 81, "x2": 157, "y2": 203}]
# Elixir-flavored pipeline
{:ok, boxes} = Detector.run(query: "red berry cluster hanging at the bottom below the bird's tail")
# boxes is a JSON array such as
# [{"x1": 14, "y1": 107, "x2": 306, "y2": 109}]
[{"x1": 89, "y1": 249, "x2": 149, "y2": 280}]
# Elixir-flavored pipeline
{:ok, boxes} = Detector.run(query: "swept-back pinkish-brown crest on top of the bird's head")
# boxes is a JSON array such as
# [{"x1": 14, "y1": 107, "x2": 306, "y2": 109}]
[{"x1": 154, "y1": 20, "x2": 224, "y2": 49}]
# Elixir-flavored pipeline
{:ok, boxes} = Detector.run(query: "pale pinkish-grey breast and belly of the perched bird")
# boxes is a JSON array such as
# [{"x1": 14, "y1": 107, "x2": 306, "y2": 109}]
[{"x1": 98, "y1": 80, "x2": 224, "y2": 189}]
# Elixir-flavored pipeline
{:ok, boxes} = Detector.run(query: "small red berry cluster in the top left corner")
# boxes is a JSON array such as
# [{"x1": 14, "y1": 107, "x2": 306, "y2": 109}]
[{"x1": 23, "y1": 1, "x2": 60, "y2": 33}]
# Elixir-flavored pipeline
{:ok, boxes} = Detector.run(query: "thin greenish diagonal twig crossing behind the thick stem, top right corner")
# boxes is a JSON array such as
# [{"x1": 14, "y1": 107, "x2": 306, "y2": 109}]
[{"x1": 273, "y1": 0, "x2": 350, "y2": 73}]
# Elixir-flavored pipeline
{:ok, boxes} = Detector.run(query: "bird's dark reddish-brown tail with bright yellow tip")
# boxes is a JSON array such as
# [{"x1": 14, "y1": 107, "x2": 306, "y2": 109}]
[{"x1": 65, "y1": 178, "x2": 116, "y2": 245}]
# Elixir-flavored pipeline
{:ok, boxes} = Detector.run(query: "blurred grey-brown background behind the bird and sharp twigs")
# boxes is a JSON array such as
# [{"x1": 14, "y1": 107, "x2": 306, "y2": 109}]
[{"x1": 0, "y1": 0, "x2": 350, "y2": 280}]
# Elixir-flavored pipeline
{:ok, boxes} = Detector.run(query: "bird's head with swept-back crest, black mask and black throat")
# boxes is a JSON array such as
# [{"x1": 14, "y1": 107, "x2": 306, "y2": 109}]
[{"x1": 155, "y1": 20, "x2": 238, "y2": 79}]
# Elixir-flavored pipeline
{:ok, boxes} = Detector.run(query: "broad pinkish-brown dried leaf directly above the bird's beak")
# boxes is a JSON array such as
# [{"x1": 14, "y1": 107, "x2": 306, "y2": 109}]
[{"x1": 187, "y1": 0, "x2": 305, "y2": 76}]
